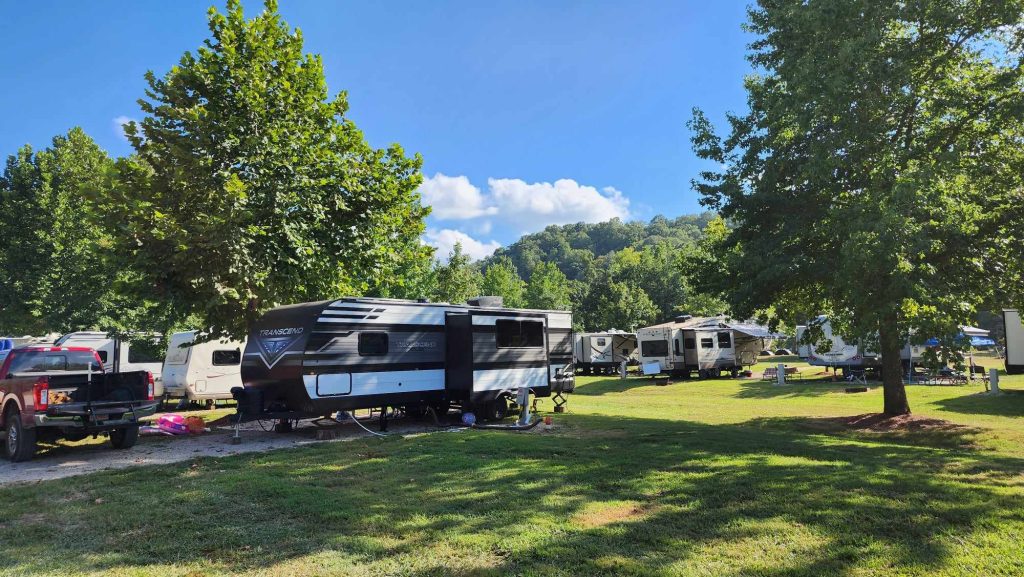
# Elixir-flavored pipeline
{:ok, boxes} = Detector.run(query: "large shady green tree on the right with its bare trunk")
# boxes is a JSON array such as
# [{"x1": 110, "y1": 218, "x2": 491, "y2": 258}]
[{"x1": 690, "y1": 0, "x2": 1024, "y2": 414}]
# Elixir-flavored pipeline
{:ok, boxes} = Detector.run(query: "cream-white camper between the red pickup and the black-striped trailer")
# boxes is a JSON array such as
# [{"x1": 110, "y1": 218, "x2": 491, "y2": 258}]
[{"x1": 164, "y1": 331, "x2": 246, "y2": 403}]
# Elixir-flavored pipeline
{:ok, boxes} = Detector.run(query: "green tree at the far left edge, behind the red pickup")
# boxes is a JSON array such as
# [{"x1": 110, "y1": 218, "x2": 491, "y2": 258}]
[{"x1": 0, "y1": 128, "x2": 123, "y2": 335}]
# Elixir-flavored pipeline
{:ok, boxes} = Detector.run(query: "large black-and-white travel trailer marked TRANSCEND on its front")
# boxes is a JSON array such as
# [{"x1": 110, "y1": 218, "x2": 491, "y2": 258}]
[{"x1": 236, "y1": 297, "x2": 573, "y2": 419}]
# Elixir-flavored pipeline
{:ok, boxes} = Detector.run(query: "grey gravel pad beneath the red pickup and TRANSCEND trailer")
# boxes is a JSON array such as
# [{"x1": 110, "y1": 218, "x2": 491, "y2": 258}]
[{"x1": 0, "y1": 419, "x2": 462, "y2": 485}]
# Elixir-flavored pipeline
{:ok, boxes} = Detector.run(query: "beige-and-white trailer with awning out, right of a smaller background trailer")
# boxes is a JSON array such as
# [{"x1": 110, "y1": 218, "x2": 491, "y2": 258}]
[{"x1": 637, "y1": 316, "x2": 781, "y2": 378}]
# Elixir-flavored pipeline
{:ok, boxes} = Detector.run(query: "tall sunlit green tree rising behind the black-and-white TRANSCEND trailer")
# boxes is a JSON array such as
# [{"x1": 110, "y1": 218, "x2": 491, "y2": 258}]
[{"x1": 109, "y1": 0, "x2": 430, "y2": 337}]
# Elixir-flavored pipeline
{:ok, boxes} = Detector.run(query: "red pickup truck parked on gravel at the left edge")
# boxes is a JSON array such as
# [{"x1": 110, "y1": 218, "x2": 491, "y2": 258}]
[{"x1": 0, "y1": 345, "x2": 157, "y2": 461}]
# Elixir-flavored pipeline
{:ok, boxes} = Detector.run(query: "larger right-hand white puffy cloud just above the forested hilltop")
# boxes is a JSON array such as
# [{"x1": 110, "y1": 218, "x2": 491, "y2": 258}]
[{"x1": 487, "y1": 178, "x2": 630, "y2": 230}]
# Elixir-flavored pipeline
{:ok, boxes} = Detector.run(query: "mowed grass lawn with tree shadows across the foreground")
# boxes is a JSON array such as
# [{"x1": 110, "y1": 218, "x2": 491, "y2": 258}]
[{"x1": 0, "y1": 362, "x2": 1024, "y2": 577}]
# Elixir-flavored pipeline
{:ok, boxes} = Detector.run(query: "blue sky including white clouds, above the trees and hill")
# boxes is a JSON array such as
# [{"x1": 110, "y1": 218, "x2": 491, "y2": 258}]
[{"x1": 0, "y1": 0, "x2": 750, "y2": 257}]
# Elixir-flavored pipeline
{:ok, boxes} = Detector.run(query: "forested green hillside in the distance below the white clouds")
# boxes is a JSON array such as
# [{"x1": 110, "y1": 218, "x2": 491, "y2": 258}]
[{"x1": 473, "y1": 212, "x2": 724, "y2": 330}]
